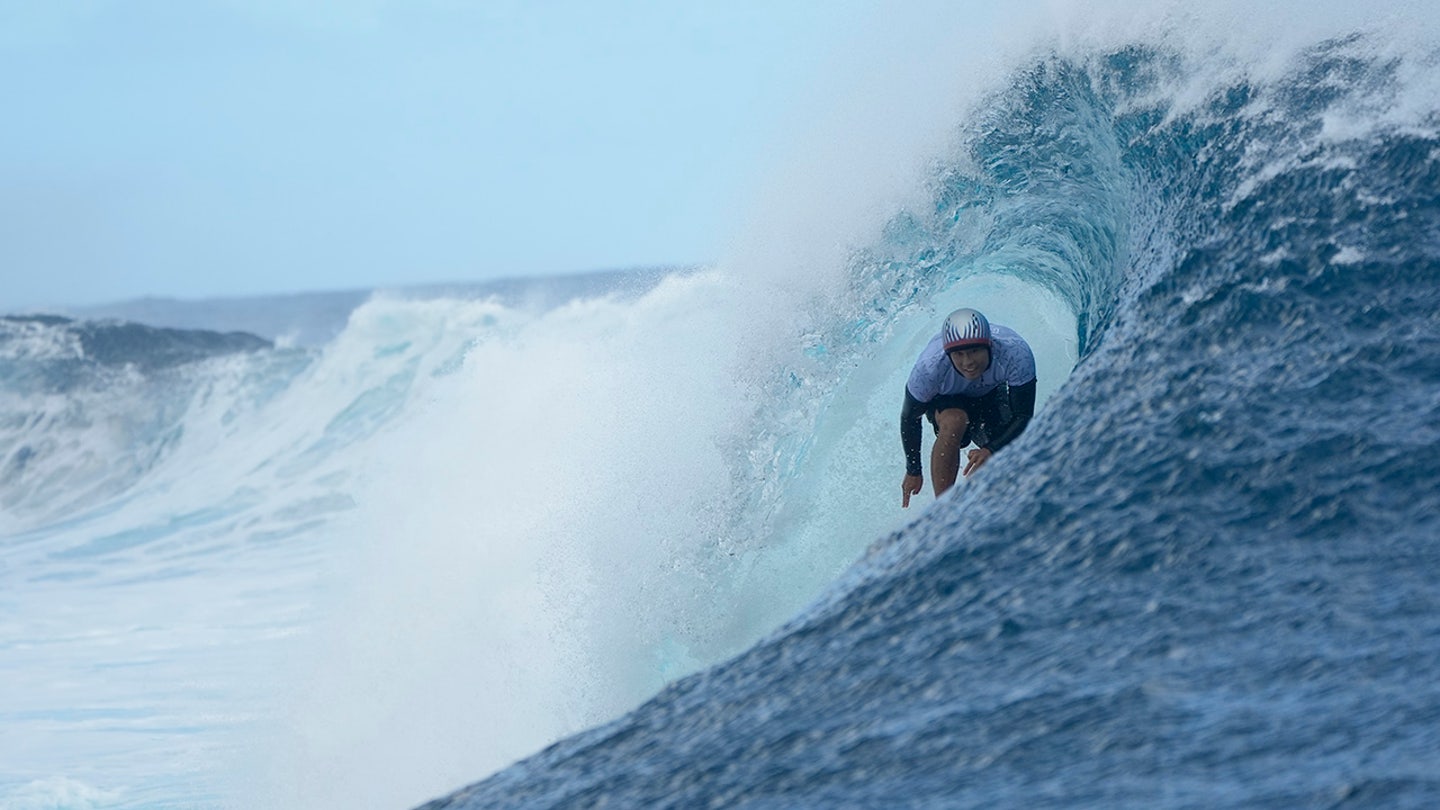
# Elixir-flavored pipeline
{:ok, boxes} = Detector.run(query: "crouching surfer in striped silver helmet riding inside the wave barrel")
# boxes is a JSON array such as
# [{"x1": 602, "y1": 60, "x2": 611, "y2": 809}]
[{"x1": 900, "y1": 310, "x2": 1035, "y2": 507}]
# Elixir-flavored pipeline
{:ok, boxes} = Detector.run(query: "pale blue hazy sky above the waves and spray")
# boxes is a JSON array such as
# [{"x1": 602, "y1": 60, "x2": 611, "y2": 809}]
[{"x1": 0, "y1": 0, "x2": 878, "y2": 311}]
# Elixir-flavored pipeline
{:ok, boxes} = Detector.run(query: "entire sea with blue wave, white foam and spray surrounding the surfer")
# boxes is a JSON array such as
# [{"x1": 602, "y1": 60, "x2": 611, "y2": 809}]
[{"x1": 0, "y1": 4, "x2": 1440, "y2": 810}]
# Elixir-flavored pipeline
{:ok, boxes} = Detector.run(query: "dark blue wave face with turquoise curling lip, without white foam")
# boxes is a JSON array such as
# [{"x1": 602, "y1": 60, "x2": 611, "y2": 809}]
[{"x1": 428, "y1": 39, "x2": 1440, "y2": 809}]
